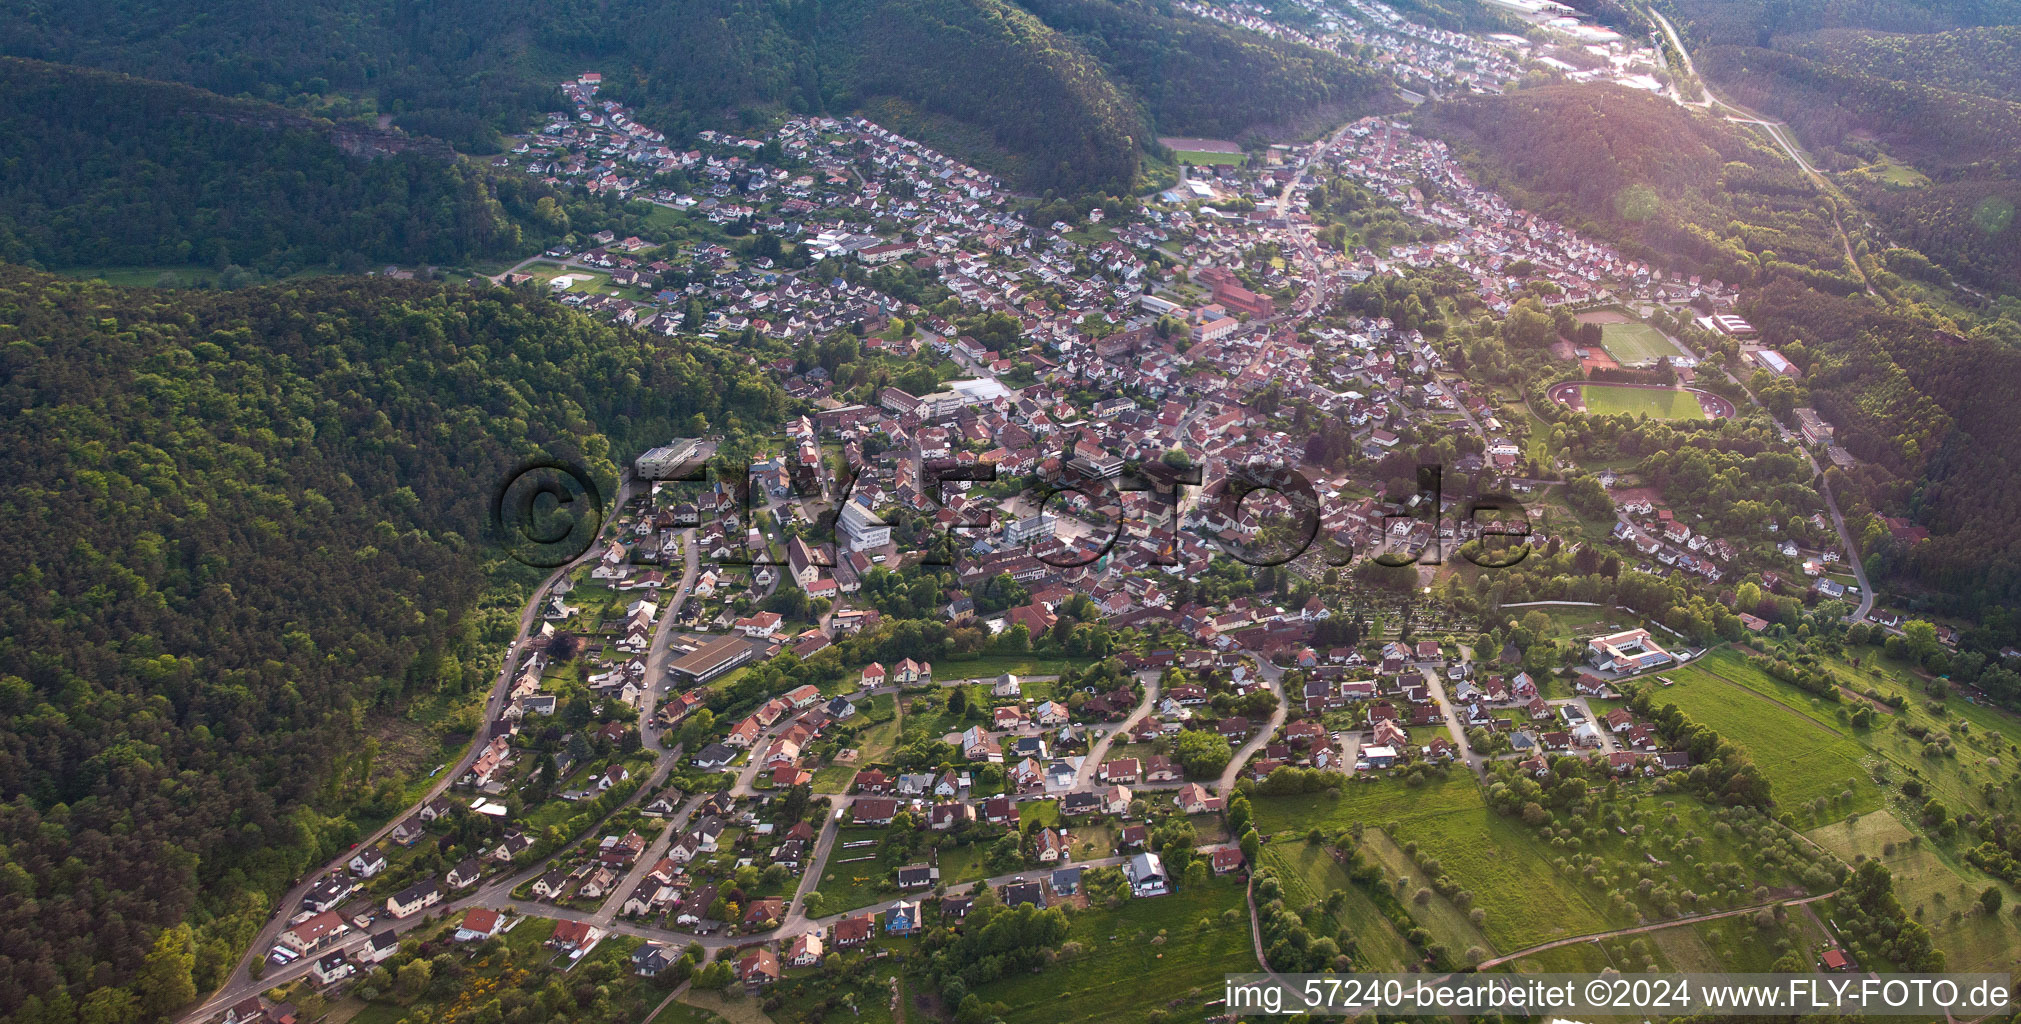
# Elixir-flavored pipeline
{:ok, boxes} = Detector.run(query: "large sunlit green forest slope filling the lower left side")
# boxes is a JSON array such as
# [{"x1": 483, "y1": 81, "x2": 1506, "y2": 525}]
[{"x1": 0, "y1": 267, "x2": 784, "y2": 1020}]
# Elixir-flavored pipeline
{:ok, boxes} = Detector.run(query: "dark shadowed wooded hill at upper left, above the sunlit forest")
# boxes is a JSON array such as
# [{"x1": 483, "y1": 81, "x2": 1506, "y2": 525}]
[{"x1": 0, "y1": 59, "x2": 521, "y2": 269}]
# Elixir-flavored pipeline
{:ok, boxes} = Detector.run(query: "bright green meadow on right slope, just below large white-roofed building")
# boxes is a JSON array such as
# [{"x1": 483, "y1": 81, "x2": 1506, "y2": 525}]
[{"x1": 1655, "y1": 650, "x2": 1882, "y2": 820}]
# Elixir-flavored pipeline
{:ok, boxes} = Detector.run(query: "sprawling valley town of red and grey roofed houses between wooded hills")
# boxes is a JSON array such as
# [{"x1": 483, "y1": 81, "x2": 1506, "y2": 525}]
[{"x1": 173, "y1": 0, "x2": 2004, "y2": 1024}]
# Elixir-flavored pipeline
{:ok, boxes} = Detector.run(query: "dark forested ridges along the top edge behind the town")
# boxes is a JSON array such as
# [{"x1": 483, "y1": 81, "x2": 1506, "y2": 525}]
[{"x1": 0, "y1": 0, "x2": 1370, "y2": 192}]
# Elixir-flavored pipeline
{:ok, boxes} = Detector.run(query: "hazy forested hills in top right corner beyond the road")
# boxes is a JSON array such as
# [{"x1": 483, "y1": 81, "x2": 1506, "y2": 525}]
[{"x1": 1673, "y1": 0, "x2": 2021, "y2": 293}]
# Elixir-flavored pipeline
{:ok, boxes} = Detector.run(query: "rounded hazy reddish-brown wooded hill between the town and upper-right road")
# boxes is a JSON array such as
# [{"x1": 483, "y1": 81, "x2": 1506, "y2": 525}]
[{"x1": 1417, "y1": 85, "x2": 1859, "y2": 291}]
